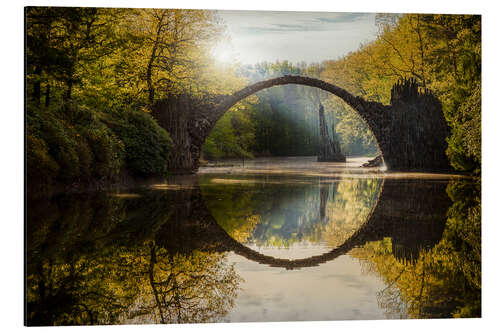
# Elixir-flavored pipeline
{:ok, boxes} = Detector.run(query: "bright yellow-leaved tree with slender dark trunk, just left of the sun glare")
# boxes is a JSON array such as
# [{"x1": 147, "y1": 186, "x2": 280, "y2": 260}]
[{"x1": 120, "y1": 9, "x2": 222, "y2": 105}]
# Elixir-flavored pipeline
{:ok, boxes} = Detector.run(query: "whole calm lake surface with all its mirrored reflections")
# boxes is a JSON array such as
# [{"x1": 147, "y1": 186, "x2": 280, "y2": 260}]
[{"x1": 26, "y1": 157, "x2": 481, "y2": 325}]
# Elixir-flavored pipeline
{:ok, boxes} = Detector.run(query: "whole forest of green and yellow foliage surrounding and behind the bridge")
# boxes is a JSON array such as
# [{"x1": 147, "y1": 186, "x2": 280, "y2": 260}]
[{"x1": 25, "y1": 7, "x2": 481, "y2": 190}]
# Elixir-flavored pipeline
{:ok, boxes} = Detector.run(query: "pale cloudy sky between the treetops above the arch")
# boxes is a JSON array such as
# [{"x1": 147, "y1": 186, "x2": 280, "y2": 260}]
[{"x1": 213, "y1": 11, "x2": 376, "y2": 64}]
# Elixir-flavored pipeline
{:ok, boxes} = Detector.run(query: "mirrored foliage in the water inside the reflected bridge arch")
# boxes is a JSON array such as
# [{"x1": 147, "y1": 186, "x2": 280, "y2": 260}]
[{"x1": 202, "y1": 178, "x2": 380, "y2": 247}]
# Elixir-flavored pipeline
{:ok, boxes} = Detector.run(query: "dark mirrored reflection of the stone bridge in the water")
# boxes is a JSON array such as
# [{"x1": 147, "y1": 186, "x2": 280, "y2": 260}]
[{"x1": 156, "y1": 180, "x2": 449, "y2": 269}]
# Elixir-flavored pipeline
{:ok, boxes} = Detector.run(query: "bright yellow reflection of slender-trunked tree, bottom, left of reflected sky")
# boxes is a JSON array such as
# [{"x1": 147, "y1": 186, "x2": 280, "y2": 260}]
[{"x1": 129, "y1": 244, "x2": 241, "y2": 323}]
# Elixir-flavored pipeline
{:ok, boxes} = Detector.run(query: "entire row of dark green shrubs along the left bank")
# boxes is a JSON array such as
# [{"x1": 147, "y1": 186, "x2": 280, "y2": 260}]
[{"x1": 26, "y1": 103, "x2": 172, "y2": 188}]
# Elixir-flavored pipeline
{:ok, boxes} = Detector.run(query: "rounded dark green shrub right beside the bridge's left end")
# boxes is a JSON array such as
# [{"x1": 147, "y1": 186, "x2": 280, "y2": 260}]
[{"x1": 102, "y1": 110, "x2": 172, "y2": 176}]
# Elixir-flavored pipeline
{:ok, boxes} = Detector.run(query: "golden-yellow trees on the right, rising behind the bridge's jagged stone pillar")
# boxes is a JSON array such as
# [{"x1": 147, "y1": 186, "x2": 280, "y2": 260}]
[{"x1": 322, "y1": 14, "x2": 481, "y2": 172}]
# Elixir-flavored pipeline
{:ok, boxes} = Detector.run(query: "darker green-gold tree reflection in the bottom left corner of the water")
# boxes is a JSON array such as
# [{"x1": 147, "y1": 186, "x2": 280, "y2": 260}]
[{"x1": 27, "y1": 244, "x2": 144, "y2": 325}]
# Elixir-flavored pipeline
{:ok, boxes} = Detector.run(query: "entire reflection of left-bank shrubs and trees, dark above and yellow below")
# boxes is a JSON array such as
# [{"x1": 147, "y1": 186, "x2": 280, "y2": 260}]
[{"x1": 26, "y1": 191, "x2": 240, "y2": 325}]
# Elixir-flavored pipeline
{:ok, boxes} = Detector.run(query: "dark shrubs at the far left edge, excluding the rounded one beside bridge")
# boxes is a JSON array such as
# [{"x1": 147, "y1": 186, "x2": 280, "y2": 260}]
[{"x1": 26, "y1": 104, "x2": 124, "y2": 184}]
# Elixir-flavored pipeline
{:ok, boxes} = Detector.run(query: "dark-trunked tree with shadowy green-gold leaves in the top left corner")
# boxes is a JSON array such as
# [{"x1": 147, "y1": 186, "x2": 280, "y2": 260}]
[{"x1": 25, "y1": 7, "x2": 120, "y2": 106}]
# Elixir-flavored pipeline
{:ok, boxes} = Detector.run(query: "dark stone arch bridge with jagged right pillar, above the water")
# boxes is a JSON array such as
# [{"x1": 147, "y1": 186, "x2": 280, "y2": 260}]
[{"x1": 152, "y1": 75, "x2": 449, "y2": 174}]
